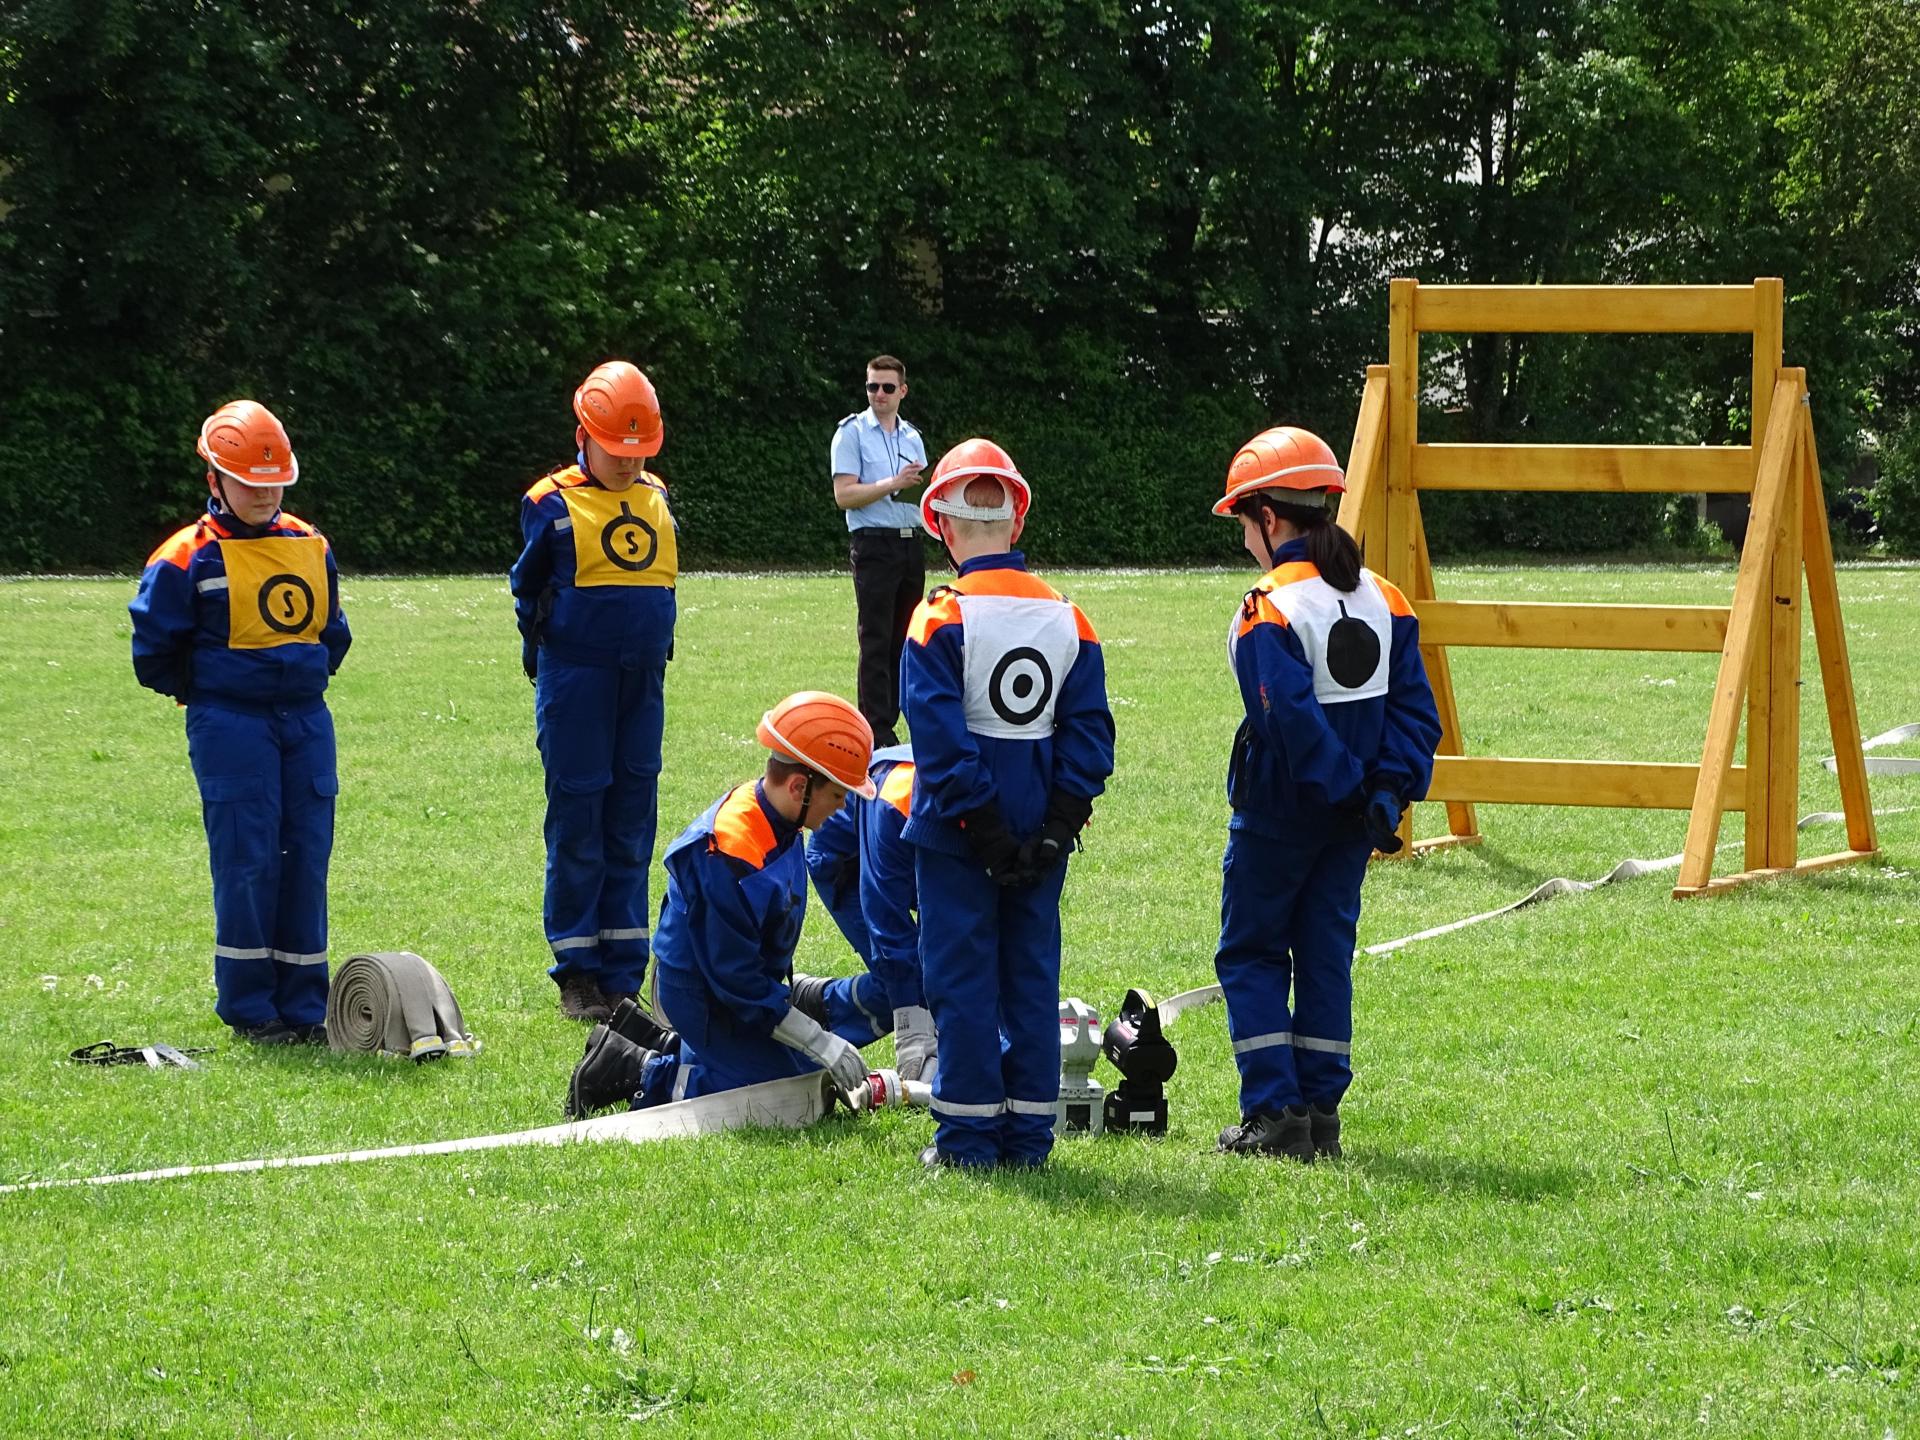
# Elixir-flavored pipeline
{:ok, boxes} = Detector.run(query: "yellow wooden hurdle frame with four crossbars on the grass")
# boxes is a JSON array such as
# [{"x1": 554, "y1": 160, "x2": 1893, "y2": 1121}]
[{"x1": 1340, "y1": 278, "x2": 1880, "y2": 899}]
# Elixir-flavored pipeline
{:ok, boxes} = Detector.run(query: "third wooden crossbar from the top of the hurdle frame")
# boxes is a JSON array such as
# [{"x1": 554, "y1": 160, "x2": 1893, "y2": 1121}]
[{"x1": 1413, "y1": 601, "x2": 1728, "y2": 655}]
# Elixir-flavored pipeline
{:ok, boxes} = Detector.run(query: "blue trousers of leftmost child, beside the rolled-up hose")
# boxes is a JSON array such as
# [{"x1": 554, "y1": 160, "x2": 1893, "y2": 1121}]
[{"x1": 186, "y1": 701, "x2": 340, "y2": 1025}]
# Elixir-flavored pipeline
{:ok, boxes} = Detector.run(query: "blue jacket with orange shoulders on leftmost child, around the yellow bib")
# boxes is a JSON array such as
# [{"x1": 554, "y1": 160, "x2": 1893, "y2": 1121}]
[{"x1": 127, "y1": 499, "x2": 353, "y2": 708}]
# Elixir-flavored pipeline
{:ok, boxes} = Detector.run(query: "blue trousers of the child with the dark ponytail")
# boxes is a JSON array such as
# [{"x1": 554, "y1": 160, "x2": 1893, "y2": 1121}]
[{"x1": 1213, "y1": 829, "x2": 1373, "y2": 1116}]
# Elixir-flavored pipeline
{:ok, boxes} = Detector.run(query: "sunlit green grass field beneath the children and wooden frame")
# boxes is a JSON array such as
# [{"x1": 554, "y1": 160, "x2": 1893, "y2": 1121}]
[{"x1": 0, "y1": 566, "x2": 1920, "y2": 1440}]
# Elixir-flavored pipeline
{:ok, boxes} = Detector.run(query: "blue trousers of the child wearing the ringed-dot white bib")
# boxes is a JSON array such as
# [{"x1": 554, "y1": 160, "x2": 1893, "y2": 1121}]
[{"x1": 914, "y1": 847, "x2": 1068, "y2": 1165}]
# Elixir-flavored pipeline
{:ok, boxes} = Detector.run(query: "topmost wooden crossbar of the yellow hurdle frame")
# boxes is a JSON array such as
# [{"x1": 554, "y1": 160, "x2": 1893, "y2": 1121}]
[{"x1": 1413, "y1": 284, "x2": 1753, "y2": 334}]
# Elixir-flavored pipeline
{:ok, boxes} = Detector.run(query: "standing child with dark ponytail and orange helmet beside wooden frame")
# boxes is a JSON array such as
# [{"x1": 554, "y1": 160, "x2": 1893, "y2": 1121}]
[{"x1": 1213, "y1": 426, "x2": 1440, "y2": 1162}]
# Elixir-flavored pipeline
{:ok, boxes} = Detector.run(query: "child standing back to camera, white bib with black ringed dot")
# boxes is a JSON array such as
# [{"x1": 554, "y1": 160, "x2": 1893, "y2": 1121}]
[{"x1": 902, "y1": 440, "x2": 1114, "y2": 1165}]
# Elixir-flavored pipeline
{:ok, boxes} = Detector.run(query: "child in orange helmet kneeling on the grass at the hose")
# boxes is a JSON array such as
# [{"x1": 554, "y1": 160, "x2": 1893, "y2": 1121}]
[{"x1": 566, "y1": 691, "x2": 894, "y2": 1116}]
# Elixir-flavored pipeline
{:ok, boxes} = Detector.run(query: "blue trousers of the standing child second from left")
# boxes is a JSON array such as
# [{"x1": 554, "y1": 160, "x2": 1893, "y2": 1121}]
[{"x1": 534, "y1": 653, "x2": 666, "y2": 995}]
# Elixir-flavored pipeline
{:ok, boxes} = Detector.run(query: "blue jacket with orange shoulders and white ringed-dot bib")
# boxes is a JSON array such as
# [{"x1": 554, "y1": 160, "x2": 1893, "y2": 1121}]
[{"x1": 900, "y1": 551, "x2": 1114, "y2": 854}]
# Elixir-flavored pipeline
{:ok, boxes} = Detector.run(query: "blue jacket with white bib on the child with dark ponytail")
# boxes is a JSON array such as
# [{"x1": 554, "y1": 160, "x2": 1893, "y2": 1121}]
[{"x1": 1227, "y1": 540, "x2": 1440, "y2": 839}]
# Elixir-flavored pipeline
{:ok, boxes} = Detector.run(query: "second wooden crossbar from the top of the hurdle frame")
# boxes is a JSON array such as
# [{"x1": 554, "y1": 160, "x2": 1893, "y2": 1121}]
[{"x1": 1413, "y1": 445, "x2": 1753, "y2": 495}]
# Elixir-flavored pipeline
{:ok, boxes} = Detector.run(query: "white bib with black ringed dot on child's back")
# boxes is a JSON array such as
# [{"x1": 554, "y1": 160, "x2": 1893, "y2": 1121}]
[{"x1": 958, "y1": 593, "x2": 1079, "y2": 739}]
